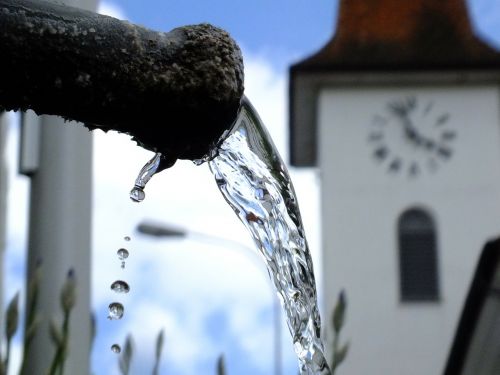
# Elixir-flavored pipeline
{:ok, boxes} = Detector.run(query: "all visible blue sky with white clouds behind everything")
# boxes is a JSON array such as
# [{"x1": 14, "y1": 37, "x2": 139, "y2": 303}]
[{"x1": 5, "y1": 0, "x2": 500, "y2": 375}]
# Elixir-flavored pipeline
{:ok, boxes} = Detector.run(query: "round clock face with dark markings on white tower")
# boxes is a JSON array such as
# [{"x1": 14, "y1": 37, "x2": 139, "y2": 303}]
[{"x1": 368, "y1": 95, "x2": 457, "y2": 177}]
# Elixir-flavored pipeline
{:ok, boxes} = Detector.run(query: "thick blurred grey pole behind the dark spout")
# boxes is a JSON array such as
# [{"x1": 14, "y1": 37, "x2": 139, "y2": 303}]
[{"x1": 21, "y1": 0, "x2": 97, "y2": 375}]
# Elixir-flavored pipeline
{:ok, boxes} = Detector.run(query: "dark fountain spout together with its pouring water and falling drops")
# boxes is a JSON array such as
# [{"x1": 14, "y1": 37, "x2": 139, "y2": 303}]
[{"x1": 0, "y1": 0, "x2": 330, "y2": 375}]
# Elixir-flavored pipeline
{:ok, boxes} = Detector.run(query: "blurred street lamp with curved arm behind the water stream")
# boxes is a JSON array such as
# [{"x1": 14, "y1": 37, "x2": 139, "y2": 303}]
[{"x1": 136, "y1": 222, "x2": 282, "y2": 375}]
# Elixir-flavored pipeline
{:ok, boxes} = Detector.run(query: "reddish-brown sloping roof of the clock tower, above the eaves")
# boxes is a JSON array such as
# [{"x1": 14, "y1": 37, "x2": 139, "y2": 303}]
[{"x1": 292, "y1": 0, "x2": 500, "y2": 71}]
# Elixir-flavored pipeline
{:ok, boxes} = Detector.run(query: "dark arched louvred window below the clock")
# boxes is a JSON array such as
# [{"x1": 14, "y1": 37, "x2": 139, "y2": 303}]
[{"x1": 398, "y1": 208, "x2": 439, "y2": 301}]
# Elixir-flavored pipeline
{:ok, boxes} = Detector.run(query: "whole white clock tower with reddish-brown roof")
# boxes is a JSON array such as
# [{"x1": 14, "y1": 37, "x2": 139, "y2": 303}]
[{"x1": 290, "y1": 0, "x2": 500, "y2": 375}]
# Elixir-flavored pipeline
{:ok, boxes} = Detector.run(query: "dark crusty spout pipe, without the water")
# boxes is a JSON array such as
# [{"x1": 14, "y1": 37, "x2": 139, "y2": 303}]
[{"x1": 0, "y1": 0, "x2": 243, "y2": 160}]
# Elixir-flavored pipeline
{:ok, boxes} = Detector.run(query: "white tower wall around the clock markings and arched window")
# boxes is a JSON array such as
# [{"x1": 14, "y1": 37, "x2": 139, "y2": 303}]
[{"x1": 318, "y1": 86, "x2": 500, "y2": 375}]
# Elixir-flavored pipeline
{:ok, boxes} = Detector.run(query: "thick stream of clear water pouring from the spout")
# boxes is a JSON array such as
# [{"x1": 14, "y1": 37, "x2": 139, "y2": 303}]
[{"x1": 208, "y1": 98, "x2": 330, "y2": 375}]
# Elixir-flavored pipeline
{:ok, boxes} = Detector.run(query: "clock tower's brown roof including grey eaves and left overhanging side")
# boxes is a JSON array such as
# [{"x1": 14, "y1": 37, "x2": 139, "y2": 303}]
[{"x1": 289, "y1": 0, "x2": 500, "y2": 166}]
